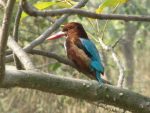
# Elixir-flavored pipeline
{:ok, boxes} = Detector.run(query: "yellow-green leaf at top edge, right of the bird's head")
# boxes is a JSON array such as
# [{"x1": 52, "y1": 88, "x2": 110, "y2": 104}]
[{"x1": 96, "y1": 0, "x2": 128, "y2": 13}]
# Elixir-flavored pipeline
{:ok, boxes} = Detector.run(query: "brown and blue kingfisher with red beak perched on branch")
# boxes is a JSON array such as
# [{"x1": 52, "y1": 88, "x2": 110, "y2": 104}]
[{"x1": 47, "y1": 22, "x2": 110, "y2": 85}]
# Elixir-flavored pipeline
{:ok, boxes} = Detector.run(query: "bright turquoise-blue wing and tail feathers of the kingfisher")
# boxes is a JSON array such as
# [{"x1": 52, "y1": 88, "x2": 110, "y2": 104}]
[{"x1": 80, "y1": 38, "x2": 104, "y2": 83}]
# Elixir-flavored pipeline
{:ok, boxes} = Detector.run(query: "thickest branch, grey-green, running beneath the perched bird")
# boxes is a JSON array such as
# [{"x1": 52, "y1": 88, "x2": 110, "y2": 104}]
[{"x1": 1, "y1": 70, "x2": 150, "y2": 113}]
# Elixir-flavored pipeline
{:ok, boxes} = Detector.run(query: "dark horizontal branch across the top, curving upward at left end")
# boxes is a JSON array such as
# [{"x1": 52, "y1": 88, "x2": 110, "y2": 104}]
[{"x1": 23, "y1": 2, "x2": 150, "y2": 22}]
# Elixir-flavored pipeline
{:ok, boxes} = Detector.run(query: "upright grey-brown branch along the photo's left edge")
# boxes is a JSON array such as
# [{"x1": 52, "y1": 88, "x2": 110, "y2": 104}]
[{"x1": 0, "y1": 0, "x2": 15, "y2": 81}]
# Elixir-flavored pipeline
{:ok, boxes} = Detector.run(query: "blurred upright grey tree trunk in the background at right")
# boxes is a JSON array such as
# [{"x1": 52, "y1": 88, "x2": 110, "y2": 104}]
[{"x1": 121, "y1": 22, "x2": 137, "y2": 88}]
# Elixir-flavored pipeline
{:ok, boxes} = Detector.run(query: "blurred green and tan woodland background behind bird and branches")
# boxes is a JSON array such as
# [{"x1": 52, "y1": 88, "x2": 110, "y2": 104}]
[{"x1": 0, "y1": 0, "x2": 150, "y2": 113}]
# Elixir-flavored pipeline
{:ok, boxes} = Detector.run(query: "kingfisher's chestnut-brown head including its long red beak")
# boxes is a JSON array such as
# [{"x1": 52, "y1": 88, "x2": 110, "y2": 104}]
[{"x1": 47, "y1": 22, "x2": 88, "y2": 40}]
